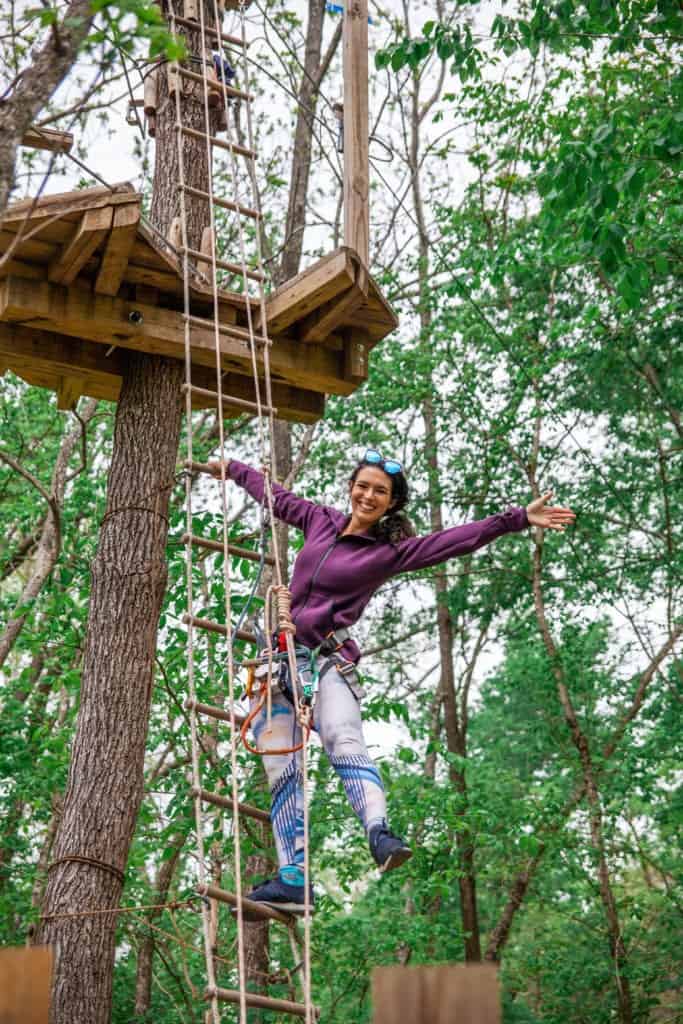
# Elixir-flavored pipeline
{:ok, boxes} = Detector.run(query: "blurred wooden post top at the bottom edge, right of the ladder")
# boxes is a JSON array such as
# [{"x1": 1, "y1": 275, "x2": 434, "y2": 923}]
[{"x1": 373, "y1": 964, "x2": 501, "y2": 1024}]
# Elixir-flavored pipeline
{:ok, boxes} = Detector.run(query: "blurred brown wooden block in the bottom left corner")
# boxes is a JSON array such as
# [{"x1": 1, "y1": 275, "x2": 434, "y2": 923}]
[{"x1": 0, "y1": 946, "x2": 52, "y2": 1024}]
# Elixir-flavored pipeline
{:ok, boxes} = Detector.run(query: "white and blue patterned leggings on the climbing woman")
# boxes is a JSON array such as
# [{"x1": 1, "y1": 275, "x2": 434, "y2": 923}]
[{"x1": 252, "y1": 657, "x2": 386, "y2": 867}]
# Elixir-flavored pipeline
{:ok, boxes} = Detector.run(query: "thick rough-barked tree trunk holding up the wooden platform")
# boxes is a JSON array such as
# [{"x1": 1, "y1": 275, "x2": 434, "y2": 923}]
[{"x1": 38, "y1": 6, "x2": 217, "y2": 1024}]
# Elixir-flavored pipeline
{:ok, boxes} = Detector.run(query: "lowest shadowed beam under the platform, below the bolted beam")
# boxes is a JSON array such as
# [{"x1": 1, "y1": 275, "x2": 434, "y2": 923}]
[{"x1": 0, "y1": 322, "x2": 325, "y2": 423}]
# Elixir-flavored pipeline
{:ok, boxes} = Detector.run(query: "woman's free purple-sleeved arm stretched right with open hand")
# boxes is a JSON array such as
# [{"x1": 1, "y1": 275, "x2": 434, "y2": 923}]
[{"x1": 393, "y1": 492, "x2": 574, "y2": 572}]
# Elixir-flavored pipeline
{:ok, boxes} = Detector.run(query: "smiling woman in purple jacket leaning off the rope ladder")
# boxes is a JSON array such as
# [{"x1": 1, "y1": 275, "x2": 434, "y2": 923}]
[{"x1": 211, "y1": 450, "x2": 574, "y2": 912}]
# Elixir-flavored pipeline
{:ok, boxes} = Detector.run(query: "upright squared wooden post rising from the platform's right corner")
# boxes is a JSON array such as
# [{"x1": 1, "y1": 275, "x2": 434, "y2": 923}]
[{"x1": 344, "y1": 0, "x2": 370, "y2": 266}]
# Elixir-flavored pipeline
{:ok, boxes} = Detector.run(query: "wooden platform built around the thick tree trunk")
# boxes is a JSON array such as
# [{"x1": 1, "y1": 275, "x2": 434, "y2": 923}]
[{"x1": 0, "y1": 184, "x2": 397, "y2": 423}]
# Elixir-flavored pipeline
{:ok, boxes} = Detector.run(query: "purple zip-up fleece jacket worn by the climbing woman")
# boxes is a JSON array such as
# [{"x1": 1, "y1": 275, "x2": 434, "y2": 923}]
[{"x1": 228, "y1": 459, "x2": 528, "y2": 662}]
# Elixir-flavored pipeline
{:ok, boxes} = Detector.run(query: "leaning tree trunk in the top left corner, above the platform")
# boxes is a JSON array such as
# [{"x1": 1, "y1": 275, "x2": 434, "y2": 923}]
[{"x1": 0, "y1": 0, "x2": 93, "y2": 216}]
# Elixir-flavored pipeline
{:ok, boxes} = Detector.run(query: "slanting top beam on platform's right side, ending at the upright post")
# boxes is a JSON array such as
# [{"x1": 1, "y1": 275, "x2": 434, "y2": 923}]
[{"x1": 264, "y1": 249, "x2": 355, "y2": 335}]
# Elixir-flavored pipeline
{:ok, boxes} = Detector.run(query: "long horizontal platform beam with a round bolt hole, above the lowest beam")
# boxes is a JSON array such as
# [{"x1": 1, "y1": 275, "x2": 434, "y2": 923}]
[{"x1": 0, "y1": 276, "x2": 354, "y2": 395}]
